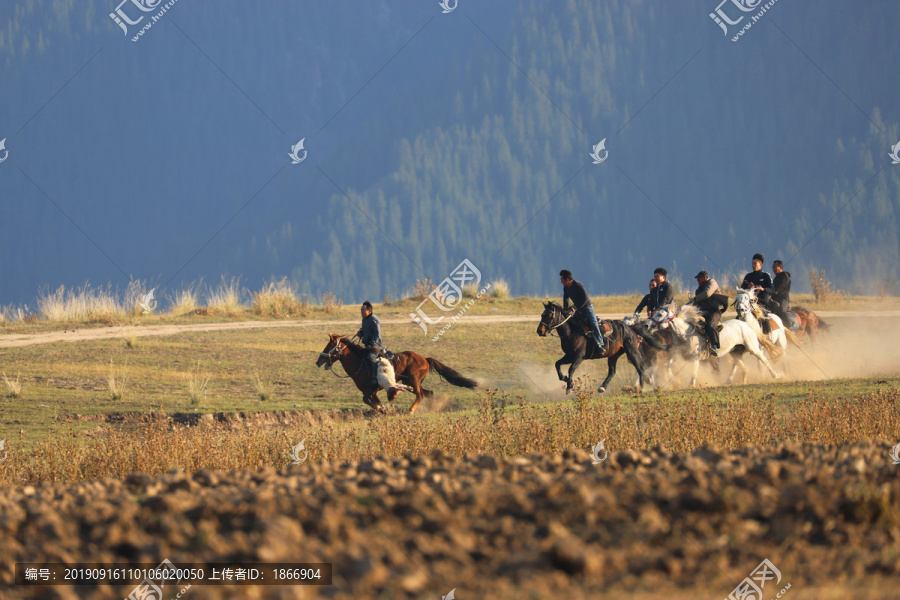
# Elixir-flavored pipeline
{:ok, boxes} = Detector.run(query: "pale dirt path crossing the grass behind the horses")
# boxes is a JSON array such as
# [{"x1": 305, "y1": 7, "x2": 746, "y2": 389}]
[{"x1": 0, "y1": 310, "x2": 888, "y2": 348}]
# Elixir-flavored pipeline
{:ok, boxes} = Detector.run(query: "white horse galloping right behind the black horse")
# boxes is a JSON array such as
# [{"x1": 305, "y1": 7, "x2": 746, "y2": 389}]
[{"x1": 644, "y1": 305, "x2": 781, "y2": 387}]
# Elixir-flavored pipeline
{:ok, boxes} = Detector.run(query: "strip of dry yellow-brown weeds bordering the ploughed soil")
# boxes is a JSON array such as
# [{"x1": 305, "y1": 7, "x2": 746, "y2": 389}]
[{"x1": 0, "y1": 374, "x2": 900, "y2": 485}]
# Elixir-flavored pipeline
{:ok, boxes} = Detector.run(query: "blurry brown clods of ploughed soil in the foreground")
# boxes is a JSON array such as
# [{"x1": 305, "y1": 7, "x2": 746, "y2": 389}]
[{"x1": 0, "y1": 440, "x2": 900, "y2": 600}]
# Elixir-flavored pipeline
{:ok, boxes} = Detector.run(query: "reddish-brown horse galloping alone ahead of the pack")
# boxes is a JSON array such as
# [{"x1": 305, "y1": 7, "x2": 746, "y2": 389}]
[{"x1": 316, "y1": 334, "x2": 478, "y2": 412}]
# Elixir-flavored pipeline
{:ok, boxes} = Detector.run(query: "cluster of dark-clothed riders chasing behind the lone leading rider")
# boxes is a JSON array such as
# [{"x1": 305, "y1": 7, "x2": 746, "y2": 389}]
[{"x1": 559, "y1": 253, "x2": 798, "y2": 352}]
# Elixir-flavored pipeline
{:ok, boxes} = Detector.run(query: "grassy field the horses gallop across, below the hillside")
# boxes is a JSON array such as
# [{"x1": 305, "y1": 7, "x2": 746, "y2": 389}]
[{"x1": 0, "y1": 298, "x2": 900, "y2": 483}]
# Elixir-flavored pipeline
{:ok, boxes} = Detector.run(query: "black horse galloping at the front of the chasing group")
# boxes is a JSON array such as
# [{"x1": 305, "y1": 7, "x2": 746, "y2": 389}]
[{"x1": 537, "y1": 302, "x2": 666, "y2": 393}]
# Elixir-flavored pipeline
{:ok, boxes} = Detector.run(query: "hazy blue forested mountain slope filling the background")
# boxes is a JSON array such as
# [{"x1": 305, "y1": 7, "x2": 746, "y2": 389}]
[{"x1": 0, "y1": 0, "x2": 900, "y2": 302}]
